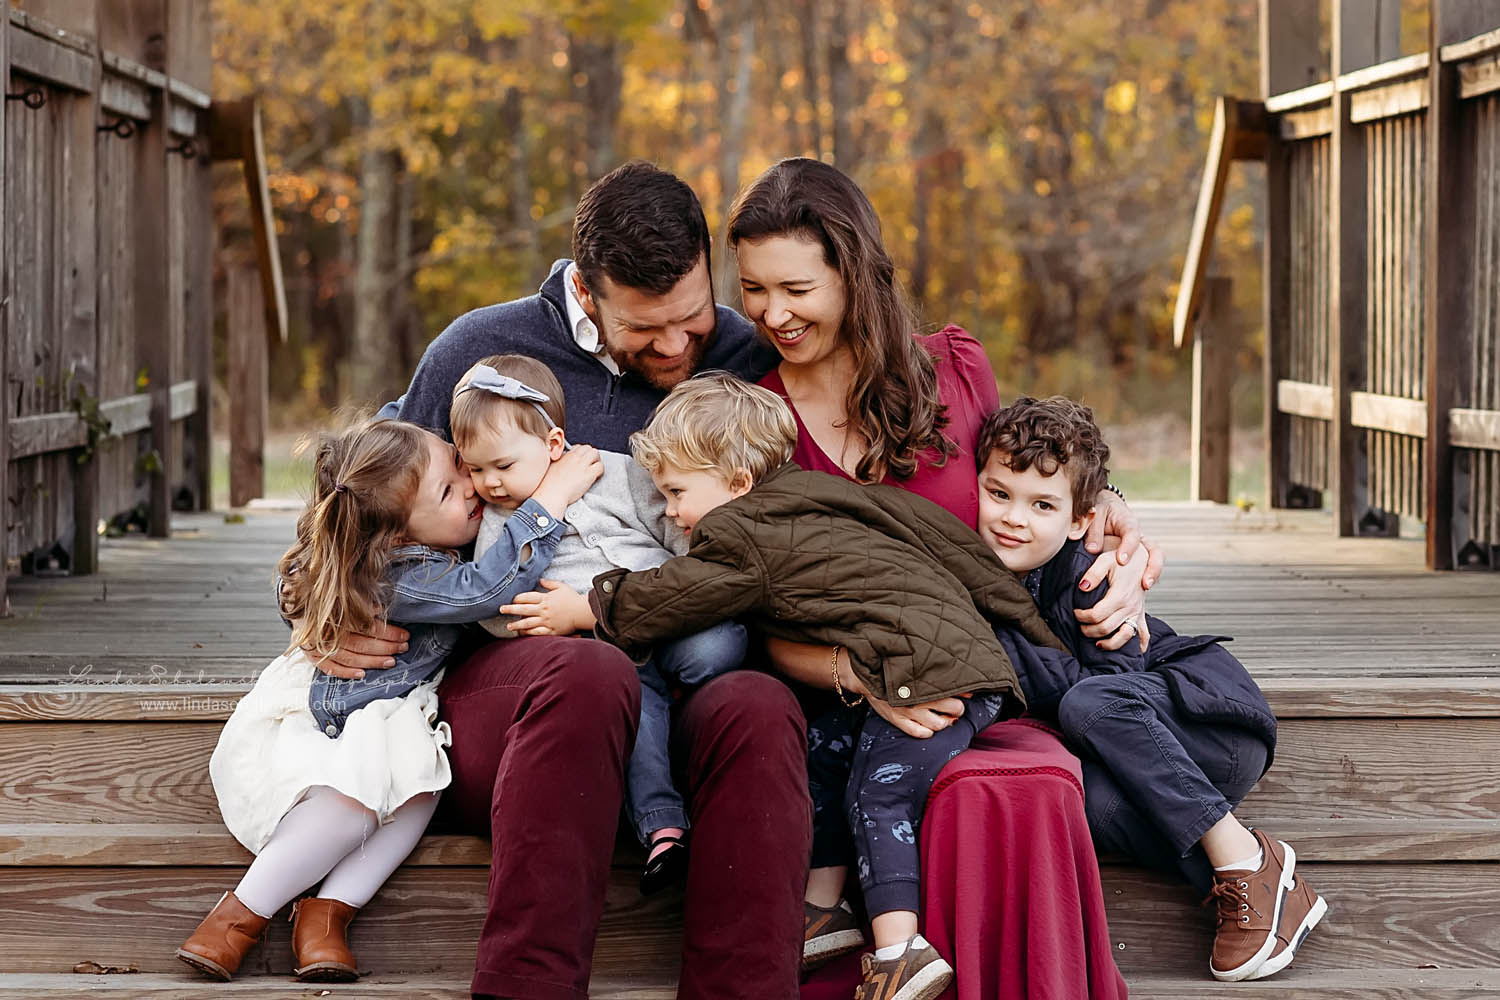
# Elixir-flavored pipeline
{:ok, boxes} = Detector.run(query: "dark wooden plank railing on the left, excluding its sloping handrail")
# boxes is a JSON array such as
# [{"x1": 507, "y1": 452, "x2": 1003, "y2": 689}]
[{"x1": 0, "y1": 0, "x2": 215, "y2": 613}]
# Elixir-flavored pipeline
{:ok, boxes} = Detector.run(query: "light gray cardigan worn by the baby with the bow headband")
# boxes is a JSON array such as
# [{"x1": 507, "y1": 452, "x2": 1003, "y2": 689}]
[{"x1": 474, "y1": 451, "x2": 687, "y2": 639}]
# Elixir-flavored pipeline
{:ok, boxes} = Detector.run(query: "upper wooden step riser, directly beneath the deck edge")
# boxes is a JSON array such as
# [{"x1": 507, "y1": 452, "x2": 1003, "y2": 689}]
[{"x1": 0, "y1": 718, "x2": 1500, "y2": 825}]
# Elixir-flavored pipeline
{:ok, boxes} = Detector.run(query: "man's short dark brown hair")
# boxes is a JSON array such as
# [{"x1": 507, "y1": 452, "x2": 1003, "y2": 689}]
[{"x1": 573, "y1": 160, "x2": 708, "y2": 295}]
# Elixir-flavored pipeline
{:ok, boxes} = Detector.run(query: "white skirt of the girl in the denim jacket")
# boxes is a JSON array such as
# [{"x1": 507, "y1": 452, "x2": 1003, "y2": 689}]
[{"x1": 209, "y1": 651, "x2": 453, "y2": 855}]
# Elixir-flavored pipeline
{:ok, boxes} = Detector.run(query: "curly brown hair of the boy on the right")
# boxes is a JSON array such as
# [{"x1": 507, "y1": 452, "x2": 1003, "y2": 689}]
[{"x1": 974, "y1": 396, "x2": 1110, "y2": 517}]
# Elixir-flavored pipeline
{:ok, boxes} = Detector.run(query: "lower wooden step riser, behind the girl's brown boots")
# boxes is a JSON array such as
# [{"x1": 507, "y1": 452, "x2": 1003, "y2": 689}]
[{"x1": 0, "y1": 862, "x2": 1500, "y2": 976}]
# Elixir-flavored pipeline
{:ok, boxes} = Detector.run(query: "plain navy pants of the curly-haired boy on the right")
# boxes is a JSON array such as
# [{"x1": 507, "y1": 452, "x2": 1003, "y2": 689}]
[{"x1": 1058, "y1": 670, "x2": 1268, "y2": 892}]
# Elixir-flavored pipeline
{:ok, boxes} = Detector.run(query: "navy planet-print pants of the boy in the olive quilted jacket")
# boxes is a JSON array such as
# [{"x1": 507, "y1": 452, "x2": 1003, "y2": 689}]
[{"x1": 807, "y1": 694, "x2": 1005, "y2": 916}]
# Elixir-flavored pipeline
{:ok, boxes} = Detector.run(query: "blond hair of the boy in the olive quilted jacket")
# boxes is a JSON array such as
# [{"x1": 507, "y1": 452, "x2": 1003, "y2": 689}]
[{"x1": 630, "y1": 372, "x2": 797, "y2": 484}]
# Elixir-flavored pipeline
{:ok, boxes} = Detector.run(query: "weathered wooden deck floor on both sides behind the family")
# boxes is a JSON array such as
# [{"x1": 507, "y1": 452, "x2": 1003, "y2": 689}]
[{"x1": 0, "y1": 504, "x2": 1500, "y2": 683}]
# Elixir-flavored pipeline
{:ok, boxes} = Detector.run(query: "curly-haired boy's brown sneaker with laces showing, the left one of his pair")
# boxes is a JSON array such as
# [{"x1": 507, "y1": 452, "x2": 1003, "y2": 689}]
[{"x1": 1203, "y1": 829, "x2": 1298, "y2": 982}]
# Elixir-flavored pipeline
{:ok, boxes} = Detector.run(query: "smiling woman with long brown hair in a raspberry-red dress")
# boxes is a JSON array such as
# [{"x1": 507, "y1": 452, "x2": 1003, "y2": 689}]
[{"x1": 729, "y1": 159, "x2": 1139, "y2": 1000}]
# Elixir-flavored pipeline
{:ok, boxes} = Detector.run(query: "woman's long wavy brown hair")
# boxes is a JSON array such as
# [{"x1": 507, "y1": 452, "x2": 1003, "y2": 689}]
[{"x1": 729, "y1": 157, "x2": 959, "y2": 483}]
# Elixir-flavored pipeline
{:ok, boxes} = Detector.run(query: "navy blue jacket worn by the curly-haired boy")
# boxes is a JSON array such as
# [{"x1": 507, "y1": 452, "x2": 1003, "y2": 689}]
[{"x1": 996, "y1": 541, "x2": 1277, "y2": 768}]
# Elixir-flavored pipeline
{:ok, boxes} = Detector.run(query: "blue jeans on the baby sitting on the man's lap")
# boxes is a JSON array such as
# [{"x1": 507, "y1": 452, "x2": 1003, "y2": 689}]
[{"x1": 626, "y1": 622, "x2": 749, "y2": 844}]
